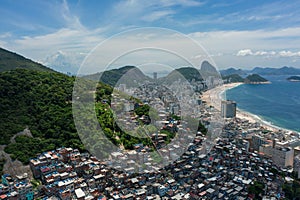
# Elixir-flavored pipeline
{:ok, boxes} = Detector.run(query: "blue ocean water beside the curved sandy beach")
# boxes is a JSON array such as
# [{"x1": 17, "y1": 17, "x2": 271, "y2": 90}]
[{"x1": 225, "y1": 76, "x2": 300, "y2": 132}]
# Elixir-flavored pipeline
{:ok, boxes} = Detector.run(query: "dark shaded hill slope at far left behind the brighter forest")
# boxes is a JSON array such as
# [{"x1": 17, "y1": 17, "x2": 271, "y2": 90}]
[{"x1": 0, "y1": 48, "x2": 54, "y2": 72}]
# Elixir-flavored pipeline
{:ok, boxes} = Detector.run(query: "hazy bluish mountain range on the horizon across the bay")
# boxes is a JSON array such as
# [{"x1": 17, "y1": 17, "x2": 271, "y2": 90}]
[{"x1": 220, "y1": 66, "x2": 300, "y2": 76}]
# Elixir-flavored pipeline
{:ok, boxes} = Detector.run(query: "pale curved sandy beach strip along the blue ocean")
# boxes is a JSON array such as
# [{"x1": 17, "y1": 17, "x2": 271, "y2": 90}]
[{"x1": 202, "y1": 83, "x2": 299, "y2": 133}]
